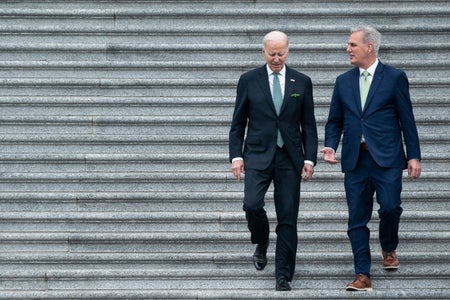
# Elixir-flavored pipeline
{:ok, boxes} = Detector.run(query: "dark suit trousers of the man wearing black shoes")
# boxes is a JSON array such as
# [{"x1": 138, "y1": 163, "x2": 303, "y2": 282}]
[{"x1": 243, "y1": 148, "x2": 301, "y2": 281}]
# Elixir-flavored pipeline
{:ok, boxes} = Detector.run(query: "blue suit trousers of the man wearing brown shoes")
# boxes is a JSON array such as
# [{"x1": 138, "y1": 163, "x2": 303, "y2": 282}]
[{"x1": 344, "y1": 150, "x2": 403, "y2": 277}]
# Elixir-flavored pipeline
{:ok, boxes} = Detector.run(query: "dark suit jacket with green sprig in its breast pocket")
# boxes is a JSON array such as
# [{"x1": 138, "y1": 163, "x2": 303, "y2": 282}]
[{"x1": 229, "y1": 65, "x2": 318, "y2": 174}]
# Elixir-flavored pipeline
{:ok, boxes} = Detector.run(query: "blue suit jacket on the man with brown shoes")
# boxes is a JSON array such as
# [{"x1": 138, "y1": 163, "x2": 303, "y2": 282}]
[{"x1": 325, "y1": 62, "x2": 421, "y2": 172}]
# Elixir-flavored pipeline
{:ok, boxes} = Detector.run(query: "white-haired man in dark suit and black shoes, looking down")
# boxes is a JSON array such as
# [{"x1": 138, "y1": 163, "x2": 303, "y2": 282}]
[{"x1": 229, "y1": 31, "x2": 318, "y2": 291}]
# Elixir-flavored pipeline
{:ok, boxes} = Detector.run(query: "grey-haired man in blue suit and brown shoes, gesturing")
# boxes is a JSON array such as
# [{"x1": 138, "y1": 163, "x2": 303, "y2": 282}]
[{"x1": 320, "y1": 26, "x2": 421, "y2": 291}]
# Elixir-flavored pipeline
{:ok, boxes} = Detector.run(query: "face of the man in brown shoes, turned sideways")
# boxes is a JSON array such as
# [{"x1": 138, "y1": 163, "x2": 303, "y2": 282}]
[{"x1": 347, "y1": 32, "x2": 373, "y2": 69}]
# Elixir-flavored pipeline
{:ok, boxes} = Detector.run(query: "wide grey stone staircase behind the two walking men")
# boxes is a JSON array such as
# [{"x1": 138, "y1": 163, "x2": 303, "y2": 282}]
[{"x1": 0, "y1": 0, "x2": 450, "y2": 300}]
